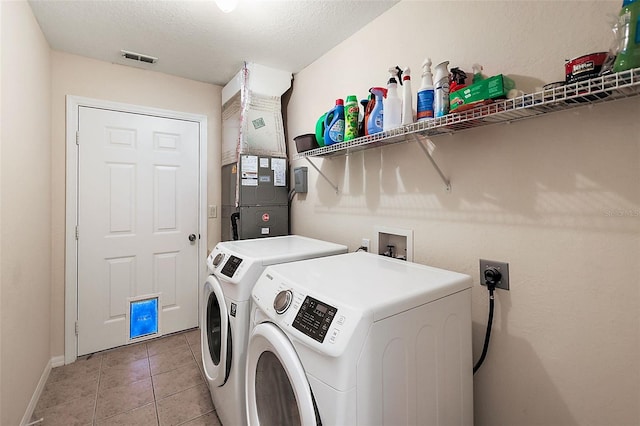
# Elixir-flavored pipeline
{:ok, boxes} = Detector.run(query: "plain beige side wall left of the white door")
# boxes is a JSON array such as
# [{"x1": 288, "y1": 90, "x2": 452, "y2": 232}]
[{"x1": 0, "y1": 1, "x2": 51, "y2": 425}]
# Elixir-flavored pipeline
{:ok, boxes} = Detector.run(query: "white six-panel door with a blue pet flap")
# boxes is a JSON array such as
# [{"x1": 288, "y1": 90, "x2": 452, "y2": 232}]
[{"x1": 76, "y1": 106, "x2": 200, "y2": 356}]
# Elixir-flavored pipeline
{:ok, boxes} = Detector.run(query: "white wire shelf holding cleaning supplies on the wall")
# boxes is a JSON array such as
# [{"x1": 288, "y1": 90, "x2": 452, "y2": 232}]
[{"x1": 294, "y1": 68, "x2": 640, "y2": 159}]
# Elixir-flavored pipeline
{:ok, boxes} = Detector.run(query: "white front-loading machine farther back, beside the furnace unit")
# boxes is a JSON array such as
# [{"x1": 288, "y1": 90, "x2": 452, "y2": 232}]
[{"x1": 200, "y1": 235, "x2": 347, "y2": 426}]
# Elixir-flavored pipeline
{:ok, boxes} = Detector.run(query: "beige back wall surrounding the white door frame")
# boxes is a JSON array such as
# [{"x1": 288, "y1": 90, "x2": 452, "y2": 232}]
[{"x1": 51, "y1": 51, "x2": 222, "y2": 356}]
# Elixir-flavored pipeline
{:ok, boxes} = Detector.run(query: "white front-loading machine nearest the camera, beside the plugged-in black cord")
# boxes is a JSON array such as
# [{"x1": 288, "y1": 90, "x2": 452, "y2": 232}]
[{"x1": 246, "y1": 252, "x2": 473, "y2": 426}]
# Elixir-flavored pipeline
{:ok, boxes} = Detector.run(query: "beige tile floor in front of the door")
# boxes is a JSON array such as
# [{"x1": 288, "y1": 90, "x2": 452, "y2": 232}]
[{"x1": 32, "y1": 329, "x2": 220, "y2": 426}]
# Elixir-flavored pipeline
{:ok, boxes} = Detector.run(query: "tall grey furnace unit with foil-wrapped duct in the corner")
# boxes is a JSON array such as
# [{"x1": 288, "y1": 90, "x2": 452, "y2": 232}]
[{"x1": 221, "y1": 63, "x2": 291, "y2": 241}]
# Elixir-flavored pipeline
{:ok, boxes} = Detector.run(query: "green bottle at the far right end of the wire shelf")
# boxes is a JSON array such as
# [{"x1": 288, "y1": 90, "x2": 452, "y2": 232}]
[{"x1": 613, "y1": 0, "x2": 640, "y2": 72}]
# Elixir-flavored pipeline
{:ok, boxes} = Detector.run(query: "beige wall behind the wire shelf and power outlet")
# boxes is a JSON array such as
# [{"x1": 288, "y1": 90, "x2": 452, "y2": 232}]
[{"x1": 287, "y1": 1, "x2": 640, "y2": 426}]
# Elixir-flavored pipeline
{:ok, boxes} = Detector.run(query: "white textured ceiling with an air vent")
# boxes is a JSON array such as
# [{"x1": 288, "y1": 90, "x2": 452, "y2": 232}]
[{"x1": 29, "y1": 0, "x2": 397, "y2": 85}]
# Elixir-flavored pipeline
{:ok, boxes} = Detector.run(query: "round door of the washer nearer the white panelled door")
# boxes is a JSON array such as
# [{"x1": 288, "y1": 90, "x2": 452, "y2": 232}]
[{"x1": 200, "y1": 276, "x2": 232, "y2": 386}]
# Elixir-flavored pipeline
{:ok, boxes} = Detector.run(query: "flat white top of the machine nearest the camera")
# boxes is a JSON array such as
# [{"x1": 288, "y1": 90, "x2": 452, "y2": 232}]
[{"x1": 258, "y1": 252, "x2": 472, "y2": 321}]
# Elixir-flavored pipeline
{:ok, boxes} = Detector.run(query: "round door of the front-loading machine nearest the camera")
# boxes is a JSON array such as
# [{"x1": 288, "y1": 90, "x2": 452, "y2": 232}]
[{"x1": 245, "y1": 323, "x2": 321, "y2": 426}]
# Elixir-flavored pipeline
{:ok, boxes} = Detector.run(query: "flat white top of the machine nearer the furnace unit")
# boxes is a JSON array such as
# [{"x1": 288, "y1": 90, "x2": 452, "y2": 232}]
[{"x1": 216, "y1": 235, "x2": 347, "y2": 266}]
